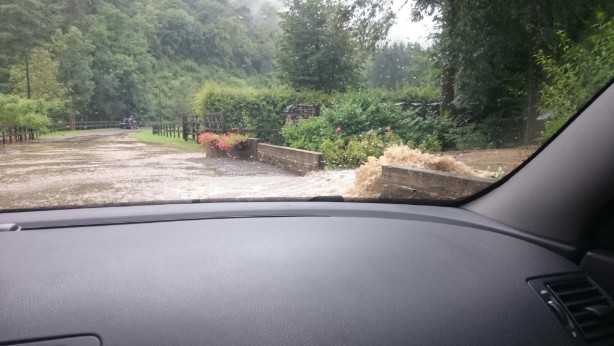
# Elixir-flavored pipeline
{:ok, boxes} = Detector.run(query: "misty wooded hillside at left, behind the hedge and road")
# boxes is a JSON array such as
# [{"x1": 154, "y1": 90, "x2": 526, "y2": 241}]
[{"x1": 0, "y1": 0, "x2": 279, "y2": 121}]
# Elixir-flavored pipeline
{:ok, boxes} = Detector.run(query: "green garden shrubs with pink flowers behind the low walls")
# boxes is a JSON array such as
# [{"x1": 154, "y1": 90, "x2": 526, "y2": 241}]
[{"x1": 282, "y1": 91, "x2": 488, "y2": 167}]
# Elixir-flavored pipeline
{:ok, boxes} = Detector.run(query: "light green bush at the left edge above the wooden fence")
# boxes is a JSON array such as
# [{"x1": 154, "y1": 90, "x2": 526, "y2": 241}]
[{"x1": 0, "y1": 94, "x2": 51, "y2": 130}]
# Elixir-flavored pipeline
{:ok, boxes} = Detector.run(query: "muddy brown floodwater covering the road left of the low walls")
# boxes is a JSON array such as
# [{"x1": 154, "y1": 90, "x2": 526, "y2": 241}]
[{"x1": 0, "y1": 130, "x2": 354, "y2": 209}]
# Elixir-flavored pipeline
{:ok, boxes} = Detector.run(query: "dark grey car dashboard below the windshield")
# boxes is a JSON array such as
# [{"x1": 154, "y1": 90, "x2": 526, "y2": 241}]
[{"x1": 0, "y1": 202, "x2": 611, "y2": 345}]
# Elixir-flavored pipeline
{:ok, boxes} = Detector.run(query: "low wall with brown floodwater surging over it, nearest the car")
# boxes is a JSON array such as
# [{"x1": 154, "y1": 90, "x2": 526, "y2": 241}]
[{"x1": 381, "y1": 166, "x2": 494, "y2": 200}]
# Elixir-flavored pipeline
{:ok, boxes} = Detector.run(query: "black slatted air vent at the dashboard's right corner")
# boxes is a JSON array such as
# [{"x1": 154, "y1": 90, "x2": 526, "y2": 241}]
[{"x1": 546, "y1": 278, "x2": 614, "y2": 341}]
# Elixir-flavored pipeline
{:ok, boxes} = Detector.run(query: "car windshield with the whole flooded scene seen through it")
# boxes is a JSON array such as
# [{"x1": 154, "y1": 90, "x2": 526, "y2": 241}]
[{"x1": 0, "y1": 0, "x2": 614, "y2": 210}]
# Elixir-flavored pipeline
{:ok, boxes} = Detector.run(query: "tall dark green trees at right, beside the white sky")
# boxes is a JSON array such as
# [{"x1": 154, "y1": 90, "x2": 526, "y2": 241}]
[{"x1": 414, "y1": 0, "x2": 614, "y2": 145}]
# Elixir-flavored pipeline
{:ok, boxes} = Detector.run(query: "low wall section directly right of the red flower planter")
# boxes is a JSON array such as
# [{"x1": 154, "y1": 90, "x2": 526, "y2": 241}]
[{"x1": 258, "y1": 143, "x2": 324, "y2": 175}]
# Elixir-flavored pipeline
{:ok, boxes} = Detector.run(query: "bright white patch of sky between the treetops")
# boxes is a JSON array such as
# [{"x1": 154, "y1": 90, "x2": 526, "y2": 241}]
[{"x1": 388, "y1": 0, "x2": 434, "y2": 47}]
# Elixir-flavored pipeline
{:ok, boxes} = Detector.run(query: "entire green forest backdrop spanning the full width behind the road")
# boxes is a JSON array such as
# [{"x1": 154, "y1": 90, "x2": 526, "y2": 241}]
[{"x1": 0, "y1": 0, "x2": 614, "y2": 149}]
